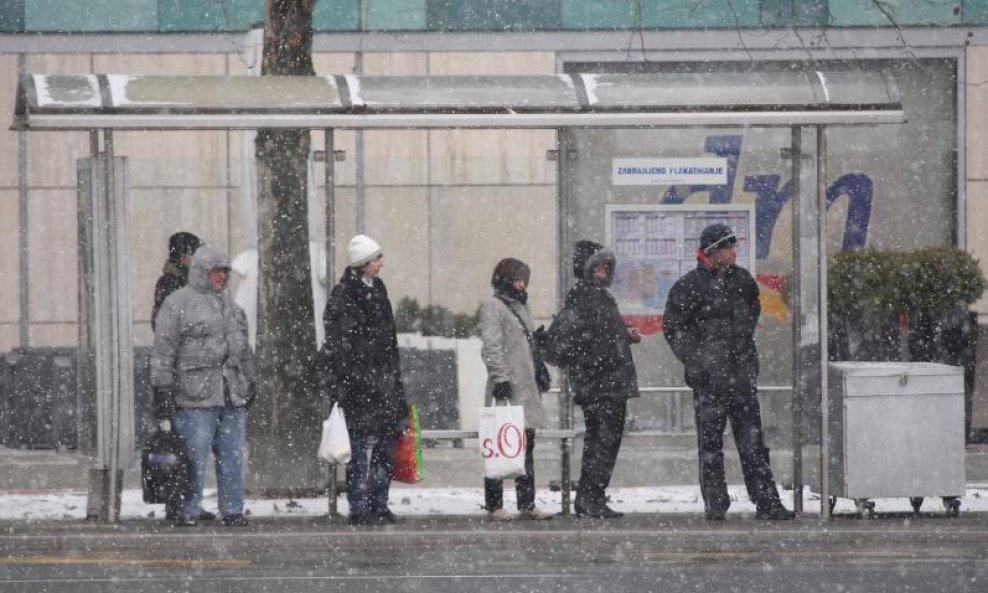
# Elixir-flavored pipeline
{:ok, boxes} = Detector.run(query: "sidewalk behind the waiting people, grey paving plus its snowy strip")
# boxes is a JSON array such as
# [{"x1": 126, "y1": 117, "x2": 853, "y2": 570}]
[{"x1": 0, "y1": 435, "x2": 988, "y2": 521}]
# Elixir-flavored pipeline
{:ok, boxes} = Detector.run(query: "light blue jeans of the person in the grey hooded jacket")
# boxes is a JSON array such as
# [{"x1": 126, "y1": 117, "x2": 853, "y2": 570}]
[{"x1": 175, "y1": 406, "x2": 247, "y2": 517}]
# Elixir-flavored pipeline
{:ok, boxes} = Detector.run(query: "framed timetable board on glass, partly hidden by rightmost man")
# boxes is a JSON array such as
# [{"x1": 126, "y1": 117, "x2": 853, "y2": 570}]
[{"x1": 606, "y1": 204, "x2": 755, "y2": 317}]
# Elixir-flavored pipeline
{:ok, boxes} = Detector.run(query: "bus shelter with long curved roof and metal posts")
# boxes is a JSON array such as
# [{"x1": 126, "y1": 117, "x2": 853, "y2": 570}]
[{"x1": 13, "y1": 71, "x2": 905, "y2": 520}]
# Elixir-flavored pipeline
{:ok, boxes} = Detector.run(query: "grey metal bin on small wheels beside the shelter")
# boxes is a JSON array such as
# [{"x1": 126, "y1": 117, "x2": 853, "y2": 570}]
[{"x1": 828, "y1": 362, "x2": 966, "y2": 518}]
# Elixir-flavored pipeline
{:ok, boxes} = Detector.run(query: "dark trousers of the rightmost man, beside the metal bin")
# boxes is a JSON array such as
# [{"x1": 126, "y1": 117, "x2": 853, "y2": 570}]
[{"x1": 693, "y1": 384, "x2": 779, "y2": 513}]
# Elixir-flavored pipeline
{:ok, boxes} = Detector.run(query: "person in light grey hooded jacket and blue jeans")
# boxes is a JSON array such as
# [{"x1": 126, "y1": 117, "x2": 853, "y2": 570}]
[{"x1": 151, "y1": 245, "x2": 257, "y2": 526}]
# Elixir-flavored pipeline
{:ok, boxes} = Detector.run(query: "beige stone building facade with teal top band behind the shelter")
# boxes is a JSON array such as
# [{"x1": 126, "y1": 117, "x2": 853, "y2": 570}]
[{"x1": 0, "y1": 0, "x2": 988, "y2": 434}]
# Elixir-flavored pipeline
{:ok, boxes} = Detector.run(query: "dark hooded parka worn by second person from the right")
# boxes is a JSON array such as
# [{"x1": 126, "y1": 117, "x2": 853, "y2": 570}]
[{"x1": 560, "y1": 280, "x2": 639, "y2": 405}]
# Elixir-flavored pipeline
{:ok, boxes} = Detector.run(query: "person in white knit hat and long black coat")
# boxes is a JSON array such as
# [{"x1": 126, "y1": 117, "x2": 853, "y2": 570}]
[{"x1": 321, "y1": 235, "x2": 408, "y2": 525}]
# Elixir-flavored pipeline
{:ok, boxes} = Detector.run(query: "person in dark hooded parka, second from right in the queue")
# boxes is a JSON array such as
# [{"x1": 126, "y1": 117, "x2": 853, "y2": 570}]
[{"x1": 555, "y1": 241, "x2": 641, "y2": 519}]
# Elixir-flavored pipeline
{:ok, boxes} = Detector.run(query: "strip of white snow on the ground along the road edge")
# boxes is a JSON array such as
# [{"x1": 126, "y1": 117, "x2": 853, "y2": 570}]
[{"x1": 0, "y1": 484, "x2": 988, "y2": 521}]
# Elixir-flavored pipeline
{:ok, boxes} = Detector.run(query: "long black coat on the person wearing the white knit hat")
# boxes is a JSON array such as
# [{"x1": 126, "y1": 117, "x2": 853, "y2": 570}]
[{"x1": 321, "y1": 269, "x2": 408, "y2": 434}]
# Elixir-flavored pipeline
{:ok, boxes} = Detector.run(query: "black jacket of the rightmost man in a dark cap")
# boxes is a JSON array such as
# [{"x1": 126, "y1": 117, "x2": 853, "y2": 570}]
[{"x1": 663, "y1": 263, "x2": 761, "y2": 389}]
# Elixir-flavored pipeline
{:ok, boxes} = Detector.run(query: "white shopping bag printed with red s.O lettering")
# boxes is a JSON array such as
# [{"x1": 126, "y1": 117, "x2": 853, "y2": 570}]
[{"x1": 478, "y1": 405, "x2": 528, "y2": 480}]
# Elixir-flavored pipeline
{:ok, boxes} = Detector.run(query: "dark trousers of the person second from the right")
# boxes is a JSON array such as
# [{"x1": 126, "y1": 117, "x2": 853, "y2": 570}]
[{"x1": 574, "y1": 398, "x2": 628, "y2": 508}]
